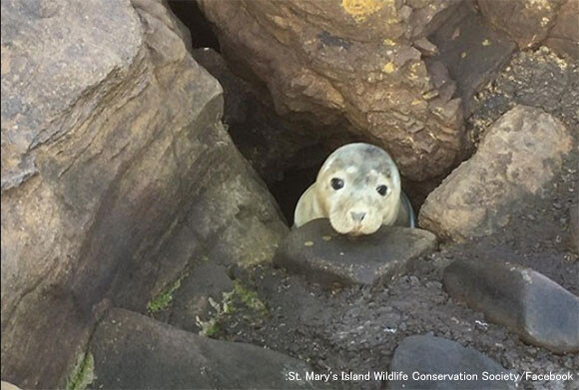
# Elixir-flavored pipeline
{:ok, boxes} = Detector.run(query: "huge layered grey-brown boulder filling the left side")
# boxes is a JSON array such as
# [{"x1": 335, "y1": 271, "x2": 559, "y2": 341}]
[{"x1": 1, "y1": 0, "x2": 287, "y2": 388}]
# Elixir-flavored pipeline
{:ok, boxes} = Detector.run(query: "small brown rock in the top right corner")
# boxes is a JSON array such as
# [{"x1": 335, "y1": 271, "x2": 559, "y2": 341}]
[{"x1": 544, "y1": 0, "x2": 579, "y2": 61}]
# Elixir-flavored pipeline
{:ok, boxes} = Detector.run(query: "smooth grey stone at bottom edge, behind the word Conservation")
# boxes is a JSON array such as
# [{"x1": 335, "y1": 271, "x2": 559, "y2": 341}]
[{"x1": 387, "y1": 335, "x2": 516, "y2": 390}]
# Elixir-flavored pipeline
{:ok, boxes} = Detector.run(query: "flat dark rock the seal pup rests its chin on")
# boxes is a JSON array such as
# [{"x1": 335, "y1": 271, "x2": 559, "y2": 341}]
[{"x1": 274, "y1": 219, "x2": 437, "y2": 287}]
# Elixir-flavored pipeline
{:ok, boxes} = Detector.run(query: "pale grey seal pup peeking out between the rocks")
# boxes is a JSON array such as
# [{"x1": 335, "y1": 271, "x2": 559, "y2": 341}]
[{"x1": 294, "y1": 143, "x2": 415, "y2": 236}]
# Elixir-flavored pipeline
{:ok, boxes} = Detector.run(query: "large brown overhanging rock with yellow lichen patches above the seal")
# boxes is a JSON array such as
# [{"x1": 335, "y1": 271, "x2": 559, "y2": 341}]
[{"x1": 200, "y1": 0, "x2": 463, "y2": 180}]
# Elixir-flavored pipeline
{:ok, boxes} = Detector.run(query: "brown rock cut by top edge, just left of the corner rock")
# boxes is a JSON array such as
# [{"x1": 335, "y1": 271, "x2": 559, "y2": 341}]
[{"x1": 478, "y1": 0, "x2": 576, "y2": 49}]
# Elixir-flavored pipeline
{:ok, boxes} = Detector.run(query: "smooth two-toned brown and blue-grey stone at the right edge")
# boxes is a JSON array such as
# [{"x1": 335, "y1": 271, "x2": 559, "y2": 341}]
[{"x1": 443, "y1": 260, "x2": 579, "y2": 353}]
